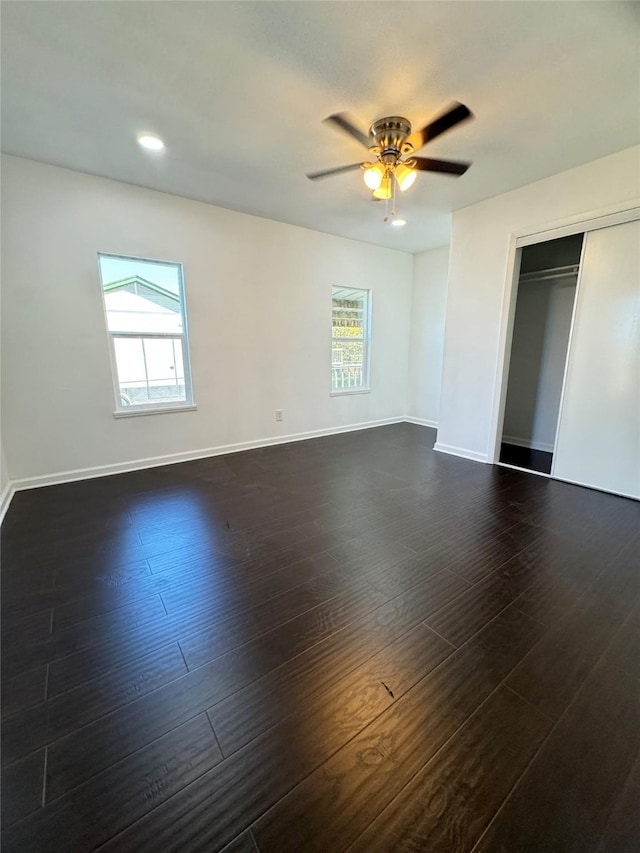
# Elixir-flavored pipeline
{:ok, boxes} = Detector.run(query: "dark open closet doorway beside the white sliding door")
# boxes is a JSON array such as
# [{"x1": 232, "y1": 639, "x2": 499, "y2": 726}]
[{"x1": 499, "y1": 234, "x2": 584, "y2": 475}]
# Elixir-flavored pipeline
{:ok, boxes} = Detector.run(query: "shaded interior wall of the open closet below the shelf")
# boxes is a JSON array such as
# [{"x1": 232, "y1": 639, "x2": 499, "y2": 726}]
[{"x1": 502, "y1": 276, "x2": 577, "y2": 453}]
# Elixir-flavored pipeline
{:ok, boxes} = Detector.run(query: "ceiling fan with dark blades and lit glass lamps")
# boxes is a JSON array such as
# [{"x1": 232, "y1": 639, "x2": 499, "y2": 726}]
[{"x1": 307, "y1": 102, "x2": 473, "y2": 199}]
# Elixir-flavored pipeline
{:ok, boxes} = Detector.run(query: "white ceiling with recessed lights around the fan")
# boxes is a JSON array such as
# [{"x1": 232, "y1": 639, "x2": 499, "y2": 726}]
[{"x1": 1, "y1": 0, "x2": 640, "y2": 252}]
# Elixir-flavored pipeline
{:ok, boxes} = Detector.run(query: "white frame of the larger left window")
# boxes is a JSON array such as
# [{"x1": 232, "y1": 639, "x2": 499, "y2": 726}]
[{"x1": 98, "y1": 252, "x2": 197, "y2": 418}]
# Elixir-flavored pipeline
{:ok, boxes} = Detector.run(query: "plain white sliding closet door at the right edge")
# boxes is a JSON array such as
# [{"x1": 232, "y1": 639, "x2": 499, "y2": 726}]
[{"x1": 552, "y1": 221, "x2": 640, "y2": 497}]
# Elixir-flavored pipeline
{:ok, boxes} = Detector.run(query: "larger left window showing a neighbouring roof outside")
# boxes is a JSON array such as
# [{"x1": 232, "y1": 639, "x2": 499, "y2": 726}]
[{"x1": 98, "y1": 254, "x2": 193, "y2": 414}]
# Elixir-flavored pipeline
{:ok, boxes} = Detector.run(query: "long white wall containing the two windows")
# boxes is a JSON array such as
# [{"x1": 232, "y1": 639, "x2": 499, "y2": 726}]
[{"x1": 2, "y1": 157, "x2": 413, "y2": 480}]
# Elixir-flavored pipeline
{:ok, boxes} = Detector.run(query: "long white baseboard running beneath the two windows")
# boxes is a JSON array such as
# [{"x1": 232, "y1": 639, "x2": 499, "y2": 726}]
[{"x1": 7, "y1": 417, "x2": 405, "y2": 492}]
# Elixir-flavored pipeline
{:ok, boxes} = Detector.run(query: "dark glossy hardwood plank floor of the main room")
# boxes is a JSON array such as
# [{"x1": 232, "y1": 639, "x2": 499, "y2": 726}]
[{"x1": 1, "y1": 424, "x2": 640, "y2": 853}]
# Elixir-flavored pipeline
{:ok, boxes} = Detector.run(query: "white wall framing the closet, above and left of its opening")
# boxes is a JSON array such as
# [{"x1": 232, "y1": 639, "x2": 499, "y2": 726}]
[{"x1": 437, "y1": 147, "x2": 640, "y2": 461}]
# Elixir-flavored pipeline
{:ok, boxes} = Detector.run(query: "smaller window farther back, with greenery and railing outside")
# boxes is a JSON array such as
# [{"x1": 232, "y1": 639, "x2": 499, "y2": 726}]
[{"x1": 331, "y1": 287, "x2": 371, "y2": 394}]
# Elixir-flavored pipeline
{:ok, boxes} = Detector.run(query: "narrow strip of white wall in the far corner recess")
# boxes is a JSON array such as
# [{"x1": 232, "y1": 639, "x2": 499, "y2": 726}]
[{"x1": 407, "y1": 246, "x2": 449, "y2": 426}]
